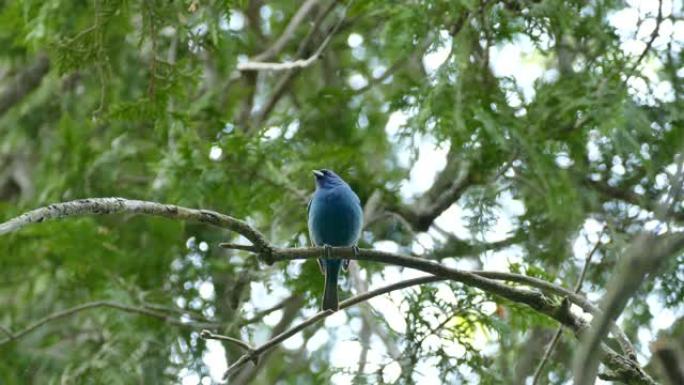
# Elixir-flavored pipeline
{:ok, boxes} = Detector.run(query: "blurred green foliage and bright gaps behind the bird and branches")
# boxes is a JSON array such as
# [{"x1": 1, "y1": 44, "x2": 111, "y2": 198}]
[{"x1": 0, "y1": 0, "x2": 684, "y2": 385}]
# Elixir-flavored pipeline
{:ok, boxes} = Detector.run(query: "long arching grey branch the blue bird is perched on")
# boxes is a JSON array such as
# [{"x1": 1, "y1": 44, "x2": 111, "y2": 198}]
[{"x1": 0, "y1": 198, "x2": 648, "y2": 384}]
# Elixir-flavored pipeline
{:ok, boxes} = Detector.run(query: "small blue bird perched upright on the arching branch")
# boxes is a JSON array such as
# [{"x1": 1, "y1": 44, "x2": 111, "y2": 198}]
[{"x1": 308, "y1": 169, "x2": 363, "y2": 310}]
